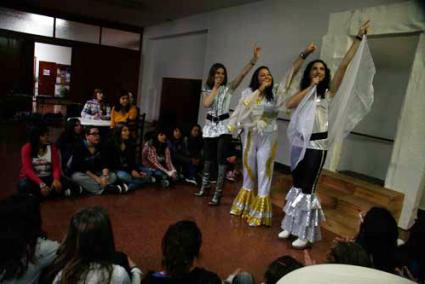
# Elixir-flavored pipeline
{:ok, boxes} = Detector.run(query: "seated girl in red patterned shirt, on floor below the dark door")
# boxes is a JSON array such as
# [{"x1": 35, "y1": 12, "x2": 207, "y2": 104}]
[{"x1": 142, "y1": 130, "x2": 177, "y2": 187}]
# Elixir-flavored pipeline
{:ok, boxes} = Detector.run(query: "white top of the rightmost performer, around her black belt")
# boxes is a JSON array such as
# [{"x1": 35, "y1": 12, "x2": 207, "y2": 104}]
[{"x1": 307, "y1": 92, "x2": 332, "y2": 150}]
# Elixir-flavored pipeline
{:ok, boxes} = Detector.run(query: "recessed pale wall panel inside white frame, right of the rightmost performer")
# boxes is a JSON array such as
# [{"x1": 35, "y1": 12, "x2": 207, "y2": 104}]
[{"x1": 338, "y1": 35, "x2": 418, "y2": 181}]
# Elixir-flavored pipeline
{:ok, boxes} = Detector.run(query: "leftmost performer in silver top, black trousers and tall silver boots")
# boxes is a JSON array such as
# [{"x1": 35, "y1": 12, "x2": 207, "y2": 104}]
[{"x1": 195, "y1": 47, "x2": 260, "y2": 206}]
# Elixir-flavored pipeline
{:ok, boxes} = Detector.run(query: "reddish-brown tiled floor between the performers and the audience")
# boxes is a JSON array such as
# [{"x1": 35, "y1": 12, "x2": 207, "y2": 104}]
[{"x1": 0, "y1": 121, "x2": 335, "y2": 281}]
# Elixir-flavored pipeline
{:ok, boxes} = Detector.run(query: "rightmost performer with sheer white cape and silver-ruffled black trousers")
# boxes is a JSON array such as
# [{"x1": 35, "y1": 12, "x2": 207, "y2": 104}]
[{"x1": 279, "y1": 21, "x2": 375, "y2": 248}]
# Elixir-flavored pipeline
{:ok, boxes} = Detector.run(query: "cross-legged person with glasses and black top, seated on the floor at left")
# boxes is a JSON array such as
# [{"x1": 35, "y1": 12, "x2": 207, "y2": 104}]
[{"x1": 71, "y1": 126, "x2": 122, "y2": 194}]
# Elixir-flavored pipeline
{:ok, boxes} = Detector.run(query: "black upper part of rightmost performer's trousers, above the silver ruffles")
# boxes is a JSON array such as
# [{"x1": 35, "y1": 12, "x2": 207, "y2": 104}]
[{"x1": 291, "y1": 149, "x2": 327, "y2": 194}]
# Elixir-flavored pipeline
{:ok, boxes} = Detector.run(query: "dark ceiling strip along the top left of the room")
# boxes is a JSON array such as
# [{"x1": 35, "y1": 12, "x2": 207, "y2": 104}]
[{"x1": 1, "y1": 0, "x2": 260, "y2": 27}]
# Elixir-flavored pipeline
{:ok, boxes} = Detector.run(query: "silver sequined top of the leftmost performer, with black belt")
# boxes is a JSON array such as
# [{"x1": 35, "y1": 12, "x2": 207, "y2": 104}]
[{"x1": 202, "y1": 84, "x2": 234, "y2": 138}]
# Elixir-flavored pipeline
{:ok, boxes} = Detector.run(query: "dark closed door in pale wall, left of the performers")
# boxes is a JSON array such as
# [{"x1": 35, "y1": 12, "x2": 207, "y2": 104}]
[{"x1": 159, "y1": 78, "x2": 202, "y2": 133}]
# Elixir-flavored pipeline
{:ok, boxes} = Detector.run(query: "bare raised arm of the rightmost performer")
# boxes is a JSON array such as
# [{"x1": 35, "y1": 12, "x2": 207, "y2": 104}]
[{"x1": 330, "y1": 20, "x2": 369, "y2": 97}]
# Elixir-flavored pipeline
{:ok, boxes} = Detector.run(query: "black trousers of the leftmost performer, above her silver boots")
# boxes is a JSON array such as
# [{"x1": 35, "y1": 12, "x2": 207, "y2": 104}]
[{"x1": 204, "y1": 134, "x2": 232, "y2": 165}]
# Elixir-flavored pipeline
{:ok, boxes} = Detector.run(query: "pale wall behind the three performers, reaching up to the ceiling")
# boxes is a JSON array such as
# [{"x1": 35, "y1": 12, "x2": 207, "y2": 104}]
[{"x1": 139, "y1": 0, "x2": 400, "y2": 164}]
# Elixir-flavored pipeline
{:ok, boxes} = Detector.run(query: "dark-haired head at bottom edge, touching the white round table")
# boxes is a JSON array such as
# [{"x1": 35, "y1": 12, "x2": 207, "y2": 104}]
[{"x1": 264, "y1": 255, "x2": 304, "y2": 284}]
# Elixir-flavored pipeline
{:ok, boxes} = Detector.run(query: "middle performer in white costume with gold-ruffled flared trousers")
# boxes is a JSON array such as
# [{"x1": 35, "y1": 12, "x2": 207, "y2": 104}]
[{"x1": 229, "y1": 44, "x2": 316, "y2": 226}]
